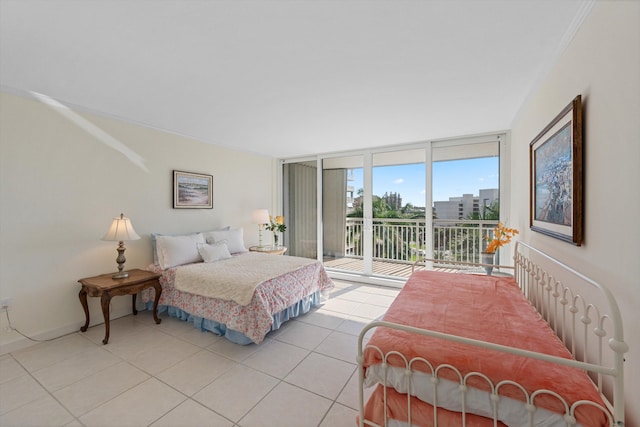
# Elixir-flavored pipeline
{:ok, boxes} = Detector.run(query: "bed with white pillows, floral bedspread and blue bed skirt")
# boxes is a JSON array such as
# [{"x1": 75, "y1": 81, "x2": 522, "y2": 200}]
[{"x1": 141, "y1": 229, "x2": 334, "y2": 345}]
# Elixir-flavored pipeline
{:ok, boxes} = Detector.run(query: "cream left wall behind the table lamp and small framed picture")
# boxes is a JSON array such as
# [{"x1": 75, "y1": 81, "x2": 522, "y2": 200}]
[{"x1": 0, "y1": 93, "x2": 275, "y2": 353}]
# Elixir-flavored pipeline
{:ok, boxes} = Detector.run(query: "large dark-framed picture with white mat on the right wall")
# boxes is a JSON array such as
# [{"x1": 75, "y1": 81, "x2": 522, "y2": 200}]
[{"x1": 529, "y1": 95, "x2": 582, "y2": 246}]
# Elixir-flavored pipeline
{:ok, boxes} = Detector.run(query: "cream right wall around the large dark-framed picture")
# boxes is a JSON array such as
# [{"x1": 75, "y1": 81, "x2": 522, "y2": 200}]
[{"x1": 511, "y1": 1, "x2": 640, "y2": 426}]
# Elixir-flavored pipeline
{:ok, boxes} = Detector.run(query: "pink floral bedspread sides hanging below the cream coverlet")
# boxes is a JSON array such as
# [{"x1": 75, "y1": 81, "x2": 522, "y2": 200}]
[{"x1": 140, "y1": 262, "x2": 334, "y2": 344}]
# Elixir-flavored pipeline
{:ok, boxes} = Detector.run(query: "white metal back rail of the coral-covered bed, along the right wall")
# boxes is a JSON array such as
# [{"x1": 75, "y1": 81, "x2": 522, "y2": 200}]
[{"x1": 514, "y1": 241, "x2": 629, "y2": 420}]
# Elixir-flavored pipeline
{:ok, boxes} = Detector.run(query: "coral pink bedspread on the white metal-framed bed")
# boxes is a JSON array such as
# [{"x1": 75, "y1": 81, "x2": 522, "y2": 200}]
[{"x1": 364, "y1": 271, "x2": 606, "y2": 426}]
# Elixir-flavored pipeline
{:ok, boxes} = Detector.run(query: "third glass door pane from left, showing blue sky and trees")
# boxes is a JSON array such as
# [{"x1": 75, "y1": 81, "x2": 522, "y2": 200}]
[{"x1": 372, "y1": 149, "x2": 426, "y2": 277}]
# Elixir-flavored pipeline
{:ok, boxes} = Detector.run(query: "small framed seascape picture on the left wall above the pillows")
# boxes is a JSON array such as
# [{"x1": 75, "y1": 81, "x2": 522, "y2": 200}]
[{"x1": 173, "y1": 170, "x2": 213, "y2": 209}]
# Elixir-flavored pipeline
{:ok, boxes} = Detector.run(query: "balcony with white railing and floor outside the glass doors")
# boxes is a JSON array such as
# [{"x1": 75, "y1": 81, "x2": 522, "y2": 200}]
[{"x1": 324, "y1": 218, "x2": 499, "y2": 278}]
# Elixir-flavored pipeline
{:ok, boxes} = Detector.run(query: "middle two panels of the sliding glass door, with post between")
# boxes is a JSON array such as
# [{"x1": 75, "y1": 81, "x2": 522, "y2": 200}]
[{"x1": 322, "y1": 148, "x2": 426, "y2": 277}]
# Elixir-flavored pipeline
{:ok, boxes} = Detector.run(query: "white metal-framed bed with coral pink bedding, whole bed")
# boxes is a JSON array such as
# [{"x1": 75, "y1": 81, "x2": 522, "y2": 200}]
[{"x1": 357, "y1": 242, "x2": 628, "y2": 427}]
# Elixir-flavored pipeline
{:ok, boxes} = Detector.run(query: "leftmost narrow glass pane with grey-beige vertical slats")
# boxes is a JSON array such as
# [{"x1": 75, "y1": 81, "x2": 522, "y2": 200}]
[{"x1": 282, "y1": 161, "x2": 318, "y2": 259}]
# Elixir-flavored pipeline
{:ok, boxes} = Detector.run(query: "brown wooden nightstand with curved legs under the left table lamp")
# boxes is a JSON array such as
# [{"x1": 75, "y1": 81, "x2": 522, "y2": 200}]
[{"x1": 78, "y1": 269, "x2": 162, "y2": 344}]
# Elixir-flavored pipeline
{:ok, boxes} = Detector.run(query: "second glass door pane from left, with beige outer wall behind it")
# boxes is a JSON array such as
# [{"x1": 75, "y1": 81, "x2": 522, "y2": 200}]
[{"x1": 322, "y1": 156, "x2": 364, "y2": 273}]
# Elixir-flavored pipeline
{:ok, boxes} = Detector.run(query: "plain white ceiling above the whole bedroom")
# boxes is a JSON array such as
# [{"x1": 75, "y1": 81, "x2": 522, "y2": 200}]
[{"x1": 0, "y1": 0, "x2": 592, "y2": 157}]
